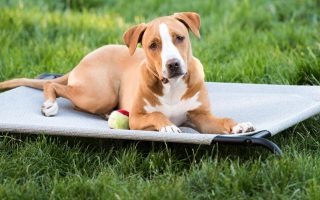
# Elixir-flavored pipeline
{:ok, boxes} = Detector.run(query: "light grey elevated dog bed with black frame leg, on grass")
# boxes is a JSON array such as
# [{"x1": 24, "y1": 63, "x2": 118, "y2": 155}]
[{"x1": 0, "y1": 75, "x2": 320, "y2": 154}]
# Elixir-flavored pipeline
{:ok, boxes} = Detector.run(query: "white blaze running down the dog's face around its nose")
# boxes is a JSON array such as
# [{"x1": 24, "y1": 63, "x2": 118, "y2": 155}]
[{"x1": 159, "y1": 23, "x2": 187, "y2": 78}]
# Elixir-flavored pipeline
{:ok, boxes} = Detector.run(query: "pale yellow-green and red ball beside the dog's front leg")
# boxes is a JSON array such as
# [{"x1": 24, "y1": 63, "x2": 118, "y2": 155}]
[{"x1": 108, "y1": 110, "x2": 129, "y2": 129}]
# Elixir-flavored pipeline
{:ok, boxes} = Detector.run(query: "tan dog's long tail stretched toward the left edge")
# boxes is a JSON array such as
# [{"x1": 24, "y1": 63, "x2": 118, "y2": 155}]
[{"x1": 0, "y1": 73, "x2": 69, "y2": 91}]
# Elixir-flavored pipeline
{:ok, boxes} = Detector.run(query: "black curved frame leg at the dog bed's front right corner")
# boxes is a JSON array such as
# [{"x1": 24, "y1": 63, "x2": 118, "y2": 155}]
[{"x1": 212, "y1": 132, "x2": 283, "y2": 157}]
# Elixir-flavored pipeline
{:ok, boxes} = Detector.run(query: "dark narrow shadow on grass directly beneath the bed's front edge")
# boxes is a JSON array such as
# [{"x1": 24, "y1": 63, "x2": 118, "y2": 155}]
[{"x1": 0, "y1": 133, "x2": 272, "y2": 164}]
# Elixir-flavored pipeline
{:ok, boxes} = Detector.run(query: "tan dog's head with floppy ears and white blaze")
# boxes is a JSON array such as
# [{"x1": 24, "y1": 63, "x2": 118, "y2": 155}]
[{"x1": 123, "y1": 12, "x2": 200, "y2": 82}]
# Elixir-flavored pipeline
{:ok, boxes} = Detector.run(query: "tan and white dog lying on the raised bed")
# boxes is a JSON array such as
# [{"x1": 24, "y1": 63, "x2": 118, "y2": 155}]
[{"x1": 0, "y1": 12, "x2": 254, "y2": 133}]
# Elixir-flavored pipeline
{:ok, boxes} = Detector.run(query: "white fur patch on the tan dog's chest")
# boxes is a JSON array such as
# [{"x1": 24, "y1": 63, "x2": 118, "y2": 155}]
[{"x1": 144, "y1": 81, "x2": 201, "y2": 126}]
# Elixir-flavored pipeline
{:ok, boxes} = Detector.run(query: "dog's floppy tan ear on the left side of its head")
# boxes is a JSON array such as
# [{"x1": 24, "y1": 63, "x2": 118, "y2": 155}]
[{"x1": 123, "y1": 23, "x2": 147, "y2": 55}]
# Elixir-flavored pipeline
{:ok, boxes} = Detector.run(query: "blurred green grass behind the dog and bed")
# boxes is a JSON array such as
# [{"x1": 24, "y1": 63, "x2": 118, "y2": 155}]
[{"x1": 0, "y1": 0, "x2": 320, "y2": 84}]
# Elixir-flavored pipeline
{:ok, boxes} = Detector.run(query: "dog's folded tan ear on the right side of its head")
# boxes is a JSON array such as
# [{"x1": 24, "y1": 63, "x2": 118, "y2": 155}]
[{"x1": 173, "y1": 12, "x2": 200, "y2": 38}]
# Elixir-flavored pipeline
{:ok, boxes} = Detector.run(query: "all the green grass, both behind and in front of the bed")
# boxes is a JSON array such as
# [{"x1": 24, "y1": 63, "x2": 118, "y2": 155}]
[{"x1": 0, "y1": 0, "x2": 320, "y2": 199}]
